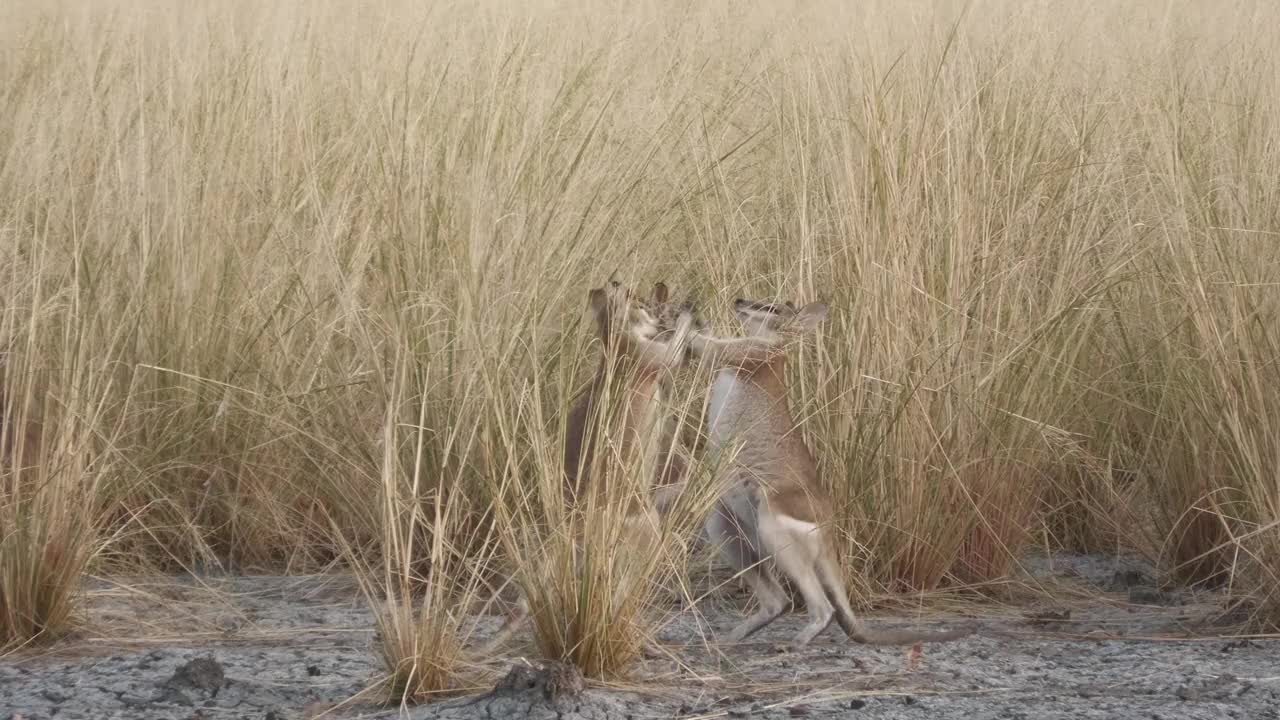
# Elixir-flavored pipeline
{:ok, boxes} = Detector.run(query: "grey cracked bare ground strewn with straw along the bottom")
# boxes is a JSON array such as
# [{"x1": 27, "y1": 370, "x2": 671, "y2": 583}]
[{"x1": 0, "y1": 557, "x2": 1280, "y2": 720}]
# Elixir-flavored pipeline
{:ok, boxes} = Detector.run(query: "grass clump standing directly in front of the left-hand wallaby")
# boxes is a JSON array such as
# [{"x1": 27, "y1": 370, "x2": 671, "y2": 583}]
[{"x1": 481, "y1": 320, "x2": 717, "y2": 679}]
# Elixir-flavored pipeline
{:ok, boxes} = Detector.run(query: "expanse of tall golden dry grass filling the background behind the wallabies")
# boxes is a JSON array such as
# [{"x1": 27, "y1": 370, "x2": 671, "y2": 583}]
[{"x1": 0, "y1": 0, "x2": 1280, "y2": 692}]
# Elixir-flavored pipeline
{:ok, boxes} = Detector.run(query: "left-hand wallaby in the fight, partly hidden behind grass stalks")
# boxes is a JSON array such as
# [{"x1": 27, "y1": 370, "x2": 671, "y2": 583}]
[{"x1": 483, "y1": 281, "x2": 692, "y2": 652}]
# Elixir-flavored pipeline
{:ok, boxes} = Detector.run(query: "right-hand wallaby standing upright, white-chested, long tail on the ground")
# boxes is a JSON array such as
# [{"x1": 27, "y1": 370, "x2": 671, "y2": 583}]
[{"x1": 689, "y1": 299, "x2": 969, "y2": 648}]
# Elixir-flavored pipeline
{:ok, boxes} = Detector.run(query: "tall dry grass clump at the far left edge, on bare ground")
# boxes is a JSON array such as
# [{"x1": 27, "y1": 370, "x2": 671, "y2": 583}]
[{"x1": 0, "y1": 242, "x2": 112, "y2": 652}]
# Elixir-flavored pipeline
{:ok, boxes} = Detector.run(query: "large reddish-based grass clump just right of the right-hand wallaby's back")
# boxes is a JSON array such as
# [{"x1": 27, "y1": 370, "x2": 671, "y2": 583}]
[{"x1": 756, "y1": 24, "x2": 1130, "y2": 589}]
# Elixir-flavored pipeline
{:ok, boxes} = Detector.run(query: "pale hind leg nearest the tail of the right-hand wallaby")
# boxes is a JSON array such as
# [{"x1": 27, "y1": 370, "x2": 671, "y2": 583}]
[{"x1": 760, "y1": 512, "x2": 835, "y2": 648}]
